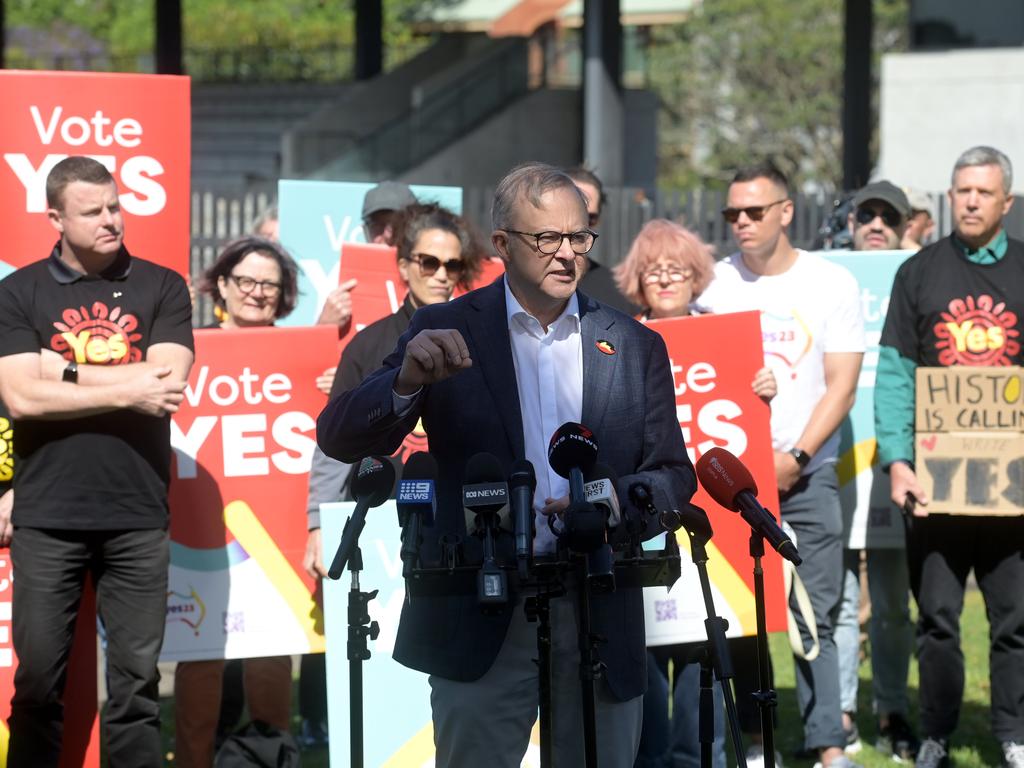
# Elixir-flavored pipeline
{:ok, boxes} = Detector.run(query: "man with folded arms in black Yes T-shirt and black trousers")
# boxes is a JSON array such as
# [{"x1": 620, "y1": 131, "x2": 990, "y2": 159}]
[{"x1": 0, "y1": 157, "x2": 193, "y2": 768}]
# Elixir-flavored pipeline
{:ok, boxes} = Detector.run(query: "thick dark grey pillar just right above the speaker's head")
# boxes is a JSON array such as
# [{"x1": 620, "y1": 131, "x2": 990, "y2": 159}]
[{"x1": 583, "y1": 0, "x2": 625, "y2": 186}]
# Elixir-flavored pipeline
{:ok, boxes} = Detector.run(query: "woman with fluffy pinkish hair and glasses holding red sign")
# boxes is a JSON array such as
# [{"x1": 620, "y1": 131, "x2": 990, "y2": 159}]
[{"x1": 615, "y1": 219, "x2": 775, "y2": 768}]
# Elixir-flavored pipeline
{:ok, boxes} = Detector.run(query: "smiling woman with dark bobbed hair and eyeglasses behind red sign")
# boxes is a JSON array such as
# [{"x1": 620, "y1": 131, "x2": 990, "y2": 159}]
[{"x1": 174, "y1": 237, "x2": 298, "y2": 768}]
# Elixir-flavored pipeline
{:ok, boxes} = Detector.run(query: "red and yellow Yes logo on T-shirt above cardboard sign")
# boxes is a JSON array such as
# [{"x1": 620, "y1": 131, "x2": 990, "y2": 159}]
[{"x1": 934, "y1": 294, "x2": 1021, "y2": 366}]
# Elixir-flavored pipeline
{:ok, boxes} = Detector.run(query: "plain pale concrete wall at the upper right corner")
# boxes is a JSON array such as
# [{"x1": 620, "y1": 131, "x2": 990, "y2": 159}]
[{"x1": 879, "y1": 48, "x2": 1024, "y2": 195}]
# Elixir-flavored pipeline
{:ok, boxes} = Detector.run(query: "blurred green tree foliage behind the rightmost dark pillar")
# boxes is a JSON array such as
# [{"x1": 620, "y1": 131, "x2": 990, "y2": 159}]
[{"x1": 648, "y1": 0, "x2": 907, "y2": 186}]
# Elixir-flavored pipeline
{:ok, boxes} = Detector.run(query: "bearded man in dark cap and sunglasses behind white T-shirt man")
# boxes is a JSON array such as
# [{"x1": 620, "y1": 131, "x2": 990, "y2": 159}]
[{"x1": 836, "y1": 181, "x2": 918, "y2": 760}]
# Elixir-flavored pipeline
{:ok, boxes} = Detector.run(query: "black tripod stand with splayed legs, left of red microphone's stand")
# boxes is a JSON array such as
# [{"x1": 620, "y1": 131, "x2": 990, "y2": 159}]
[{"x1": 684, "y1": 520, "x2": 749, "y2": 768}]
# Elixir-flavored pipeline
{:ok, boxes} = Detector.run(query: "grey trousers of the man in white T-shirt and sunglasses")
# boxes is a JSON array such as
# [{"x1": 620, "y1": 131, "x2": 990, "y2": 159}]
[{"x1": 779, "y1": 464, "x2": 846, "y2": 749}]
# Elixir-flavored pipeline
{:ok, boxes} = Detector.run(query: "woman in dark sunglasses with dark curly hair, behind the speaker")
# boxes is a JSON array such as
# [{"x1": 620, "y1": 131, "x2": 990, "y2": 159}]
[{"x1": 303, "y1": 203, "x2": 482, "y2": 579}]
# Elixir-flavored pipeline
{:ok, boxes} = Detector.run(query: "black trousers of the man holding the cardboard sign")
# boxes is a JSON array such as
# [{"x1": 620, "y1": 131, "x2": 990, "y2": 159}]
[{"x1": 907, "y1": 514, "x2": 1024, "y2": 741}]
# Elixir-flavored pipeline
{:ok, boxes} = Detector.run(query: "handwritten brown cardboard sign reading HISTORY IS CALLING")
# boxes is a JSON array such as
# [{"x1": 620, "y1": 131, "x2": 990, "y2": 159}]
[{"x1": 914, "y1": 367, "x2": 1024, "y2": 515}]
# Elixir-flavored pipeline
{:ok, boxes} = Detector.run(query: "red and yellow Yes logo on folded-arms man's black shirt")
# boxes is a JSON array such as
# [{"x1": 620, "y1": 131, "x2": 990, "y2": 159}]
[{"x1": 50, "y1": 301, "x2": 142, "y2": 365}]
